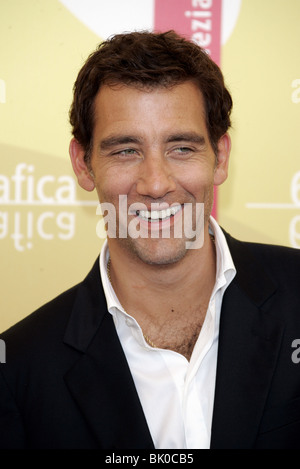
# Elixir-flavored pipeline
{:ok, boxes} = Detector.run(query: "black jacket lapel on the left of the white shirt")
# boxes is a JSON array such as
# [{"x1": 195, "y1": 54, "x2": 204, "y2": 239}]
[{"x1": 64, "y1": 261, "x2": 154, "y2": 449}]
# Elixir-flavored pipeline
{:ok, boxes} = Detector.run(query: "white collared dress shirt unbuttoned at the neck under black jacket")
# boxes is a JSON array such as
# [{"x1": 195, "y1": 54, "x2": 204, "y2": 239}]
[{"x1": 100, "y1": 217, "x2": 236, "y2": 449}]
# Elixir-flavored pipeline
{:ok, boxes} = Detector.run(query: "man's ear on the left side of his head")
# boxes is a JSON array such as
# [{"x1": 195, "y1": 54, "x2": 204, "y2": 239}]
[{"x1": 69, "y1": 138, "x2": 95, "y2": 192}]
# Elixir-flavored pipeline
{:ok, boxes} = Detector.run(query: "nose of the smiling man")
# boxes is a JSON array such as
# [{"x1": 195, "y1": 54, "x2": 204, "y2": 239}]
[{"x1": 136, "y1": 155, "x2": 176, "y2": 199}]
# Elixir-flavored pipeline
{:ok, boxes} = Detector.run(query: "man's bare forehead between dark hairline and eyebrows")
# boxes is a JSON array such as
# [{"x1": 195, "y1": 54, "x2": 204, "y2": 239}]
[{"x1": 94, "y1": 82, "x2": 207, "y2": 142}]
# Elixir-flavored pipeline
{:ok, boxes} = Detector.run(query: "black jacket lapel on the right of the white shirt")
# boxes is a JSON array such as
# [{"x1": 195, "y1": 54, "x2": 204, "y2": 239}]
[{"x1": 211, "y1": 234, "x2": 283, "y2": 449}]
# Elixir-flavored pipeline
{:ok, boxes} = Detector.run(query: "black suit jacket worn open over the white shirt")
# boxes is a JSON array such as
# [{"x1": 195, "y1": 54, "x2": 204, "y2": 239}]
[{"x1": 0, "y1": 235, "x2": 300, "y2": 449}]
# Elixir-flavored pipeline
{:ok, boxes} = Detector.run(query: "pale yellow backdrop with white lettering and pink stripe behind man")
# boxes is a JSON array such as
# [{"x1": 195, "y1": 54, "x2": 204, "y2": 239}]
[{"x1": 0, "y1": 0, "x2": 300, "y2": 330}]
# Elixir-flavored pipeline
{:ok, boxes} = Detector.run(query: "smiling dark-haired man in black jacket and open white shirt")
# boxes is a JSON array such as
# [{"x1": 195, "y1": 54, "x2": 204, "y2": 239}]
[{"x1": 0, "y1": 31, "x2": 300, "y2": 449}]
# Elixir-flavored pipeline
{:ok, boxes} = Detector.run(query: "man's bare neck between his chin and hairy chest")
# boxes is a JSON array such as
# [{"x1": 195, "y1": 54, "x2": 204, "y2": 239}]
[{"x1": 105, "y1": 229, "x2": 216, "y2": 325}]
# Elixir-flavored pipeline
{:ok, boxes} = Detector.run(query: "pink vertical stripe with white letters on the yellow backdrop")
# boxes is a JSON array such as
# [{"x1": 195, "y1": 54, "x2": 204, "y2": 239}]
[{"x1": 154, "y1": 0, "x2": 222, "y2": 218}]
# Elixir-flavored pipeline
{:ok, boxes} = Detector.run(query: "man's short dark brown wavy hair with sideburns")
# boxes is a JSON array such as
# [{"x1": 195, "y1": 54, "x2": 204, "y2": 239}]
[{"x1": 70, "y1": 31, "x2": 232, "y2": 161}]
